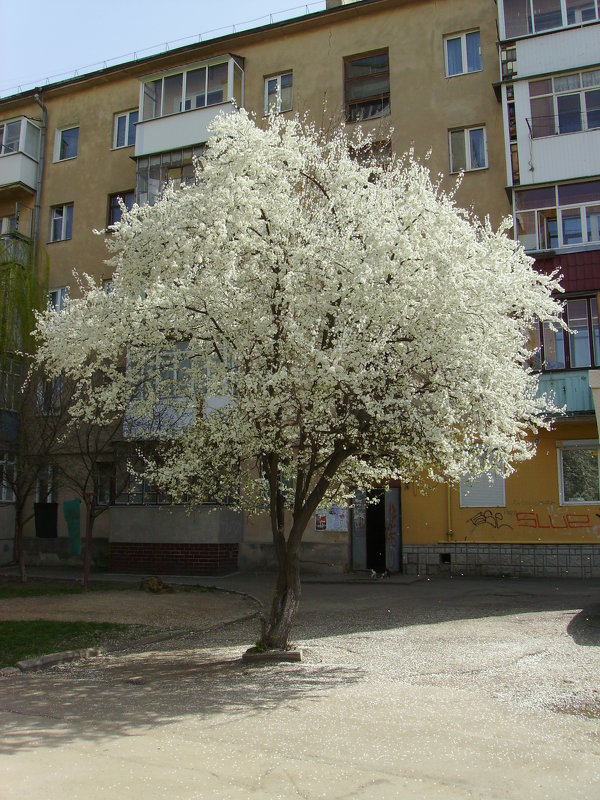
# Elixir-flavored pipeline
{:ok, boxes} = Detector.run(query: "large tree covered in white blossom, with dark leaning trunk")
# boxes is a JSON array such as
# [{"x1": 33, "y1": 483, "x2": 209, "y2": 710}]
[{"x1": 39, "y1": 111, "x2": 560, "y2": 647}]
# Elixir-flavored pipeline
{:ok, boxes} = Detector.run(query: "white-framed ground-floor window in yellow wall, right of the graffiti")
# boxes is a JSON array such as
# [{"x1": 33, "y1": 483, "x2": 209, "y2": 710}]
[{"x1": 557, "y1": 440, "x2": 600, "y2": 505}]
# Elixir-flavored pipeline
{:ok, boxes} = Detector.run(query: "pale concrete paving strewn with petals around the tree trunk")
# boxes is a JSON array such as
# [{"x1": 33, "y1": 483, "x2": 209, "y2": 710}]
[{"x1": 0, "y1": 575, "x2": 600, "y2": 800}]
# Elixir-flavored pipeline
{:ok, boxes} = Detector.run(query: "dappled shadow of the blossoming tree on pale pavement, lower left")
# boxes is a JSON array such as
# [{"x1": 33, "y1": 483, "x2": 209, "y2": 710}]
[{"x1": 0, "y1": 641, "x2": 362, "y2": 755}]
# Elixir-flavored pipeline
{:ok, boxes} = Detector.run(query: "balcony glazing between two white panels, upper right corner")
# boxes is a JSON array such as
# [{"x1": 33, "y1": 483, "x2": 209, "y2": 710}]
[{"x1": 529, "y1": 69, "x2": 600, "y2": 139}]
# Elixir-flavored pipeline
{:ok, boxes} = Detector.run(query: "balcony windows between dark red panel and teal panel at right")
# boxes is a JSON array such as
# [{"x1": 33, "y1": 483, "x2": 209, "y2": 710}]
[{"x1": 533, "y1": 295, "x2": 600, "y2": 371}]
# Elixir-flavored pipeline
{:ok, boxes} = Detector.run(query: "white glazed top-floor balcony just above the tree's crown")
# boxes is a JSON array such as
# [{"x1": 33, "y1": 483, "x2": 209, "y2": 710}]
[{"x1": 135, "y1": 55, "x2": 244, "y2": 158}]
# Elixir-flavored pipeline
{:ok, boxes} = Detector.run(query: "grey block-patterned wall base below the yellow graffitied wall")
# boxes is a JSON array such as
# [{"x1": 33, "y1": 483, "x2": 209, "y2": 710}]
[{"x1": 403, "y1": 542, "x2": 600, "y2": 578}]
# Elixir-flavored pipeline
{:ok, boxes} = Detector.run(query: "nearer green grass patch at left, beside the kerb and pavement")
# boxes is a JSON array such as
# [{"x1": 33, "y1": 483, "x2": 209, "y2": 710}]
[{"x1": 0, "y1": 620, "x2": 147, "y2": 667}]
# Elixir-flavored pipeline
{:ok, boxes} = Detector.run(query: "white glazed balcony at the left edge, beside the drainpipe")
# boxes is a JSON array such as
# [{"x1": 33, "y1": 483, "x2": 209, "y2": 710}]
[{"x1": 0, "y1": 117, "x2": 40, "y2": 198}]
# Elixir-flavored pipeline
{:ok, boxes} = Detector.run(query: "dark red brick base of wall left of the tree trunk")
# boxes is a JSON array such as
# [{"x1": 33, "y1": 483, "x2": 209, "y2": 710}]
[{"x1": 109, "y1": 542, "x2": 238, "y2": 575}]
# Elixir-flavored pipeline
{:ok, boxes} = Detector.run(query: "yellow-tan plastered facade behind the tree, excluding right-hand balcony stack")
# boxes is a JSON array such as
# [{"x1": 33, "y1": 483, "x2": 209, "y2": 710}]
[{"x1": 0, "y1": 0, "x2": 600, "y2": 575}]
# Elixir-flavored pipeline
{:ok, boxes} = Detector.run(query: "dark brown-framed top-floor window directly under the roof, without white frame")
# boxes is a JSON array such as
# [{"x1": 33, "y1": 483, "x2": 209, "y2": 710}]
[{"x1": 344, "y1": 50, "x2": 390, "y2": 122}]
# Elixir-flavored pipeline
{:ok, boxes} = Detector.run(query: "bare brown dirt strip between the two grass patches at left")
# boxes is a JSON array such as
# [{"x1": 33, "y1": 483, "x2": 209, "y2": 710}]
[{"x1": 0, "y1": 588, "x2": 257, "y2": 631}]
